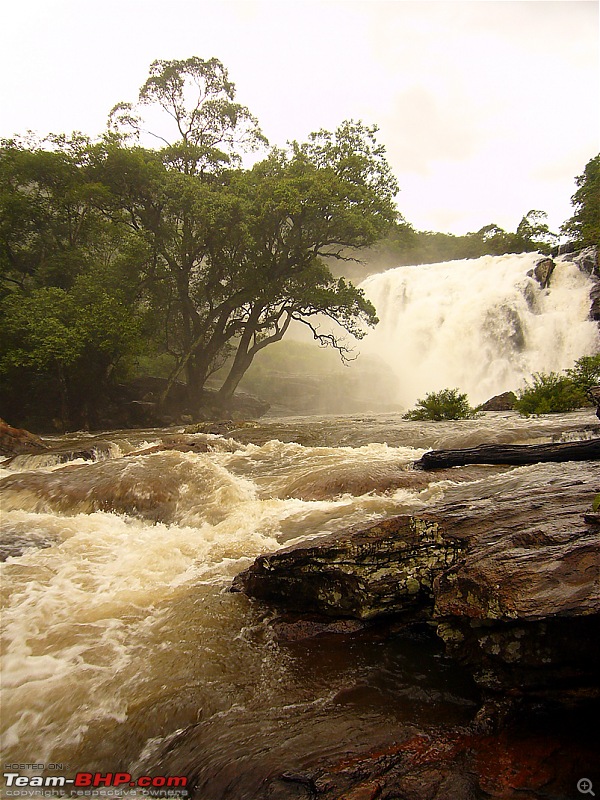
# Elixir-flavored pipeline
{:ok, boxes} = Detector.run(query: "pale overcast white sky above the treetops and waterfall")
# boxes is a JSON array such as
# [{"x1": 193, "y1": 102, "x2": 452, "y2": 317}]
[{"x1": 0, "y1": 0, "x2": 600, "y2": 234}]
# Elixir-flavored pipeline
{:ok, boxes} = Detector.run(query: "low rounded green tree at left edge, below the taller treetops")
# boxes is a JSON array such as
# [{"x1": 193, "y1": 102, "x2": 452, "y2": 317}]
[{"x1": 0, "y1": 275, "x2": 139, "y2": 428}]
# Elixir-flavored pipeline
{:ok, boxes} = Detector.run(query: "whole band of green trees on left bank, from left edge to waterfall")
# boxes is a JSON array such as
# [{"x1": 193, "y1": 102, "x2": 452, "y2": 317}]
[{"x1": 0, "y1": 57, "x2": 398, "y2": 421}]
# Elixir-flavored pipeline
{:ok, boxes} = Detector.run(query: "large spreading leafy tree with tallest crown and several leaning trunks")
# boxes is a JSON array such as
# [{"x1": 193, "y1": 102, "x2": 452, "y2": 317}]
[{"x1": 99, "y1": 59, "x2": 397, "y2": 402}]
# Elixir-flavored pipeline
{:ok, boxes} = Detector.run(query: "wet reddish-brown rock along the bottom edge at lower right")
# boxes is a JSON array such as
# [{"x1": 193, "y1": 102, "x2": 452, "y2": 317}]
[{"x1": 288, "y1": 718, "x2": 598, "y2": 800}]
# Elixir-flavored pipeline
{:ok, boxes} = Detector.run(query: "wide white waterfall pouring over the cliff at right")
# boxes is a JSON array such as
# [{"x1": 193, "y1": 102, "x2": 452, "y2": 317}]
[{"x1": 360, "y1": 253, "x2": 600, "y2": 406}]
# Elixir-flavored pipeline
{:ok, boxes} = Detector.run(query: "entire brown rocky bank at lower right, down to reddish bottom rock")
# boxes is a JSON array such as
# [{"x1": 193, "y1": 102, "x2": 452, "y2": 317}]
[{"x1": 233, "y1": 454, "x2": 600, "y2": 800}]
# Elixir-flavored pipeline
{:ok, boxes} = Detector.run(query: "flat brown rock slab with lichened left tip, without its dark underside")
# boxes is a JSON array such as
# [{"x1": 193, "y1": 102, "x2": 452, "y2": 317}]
[{"x1": 233, "y1": 462, "x2": 600, "y2": 620}]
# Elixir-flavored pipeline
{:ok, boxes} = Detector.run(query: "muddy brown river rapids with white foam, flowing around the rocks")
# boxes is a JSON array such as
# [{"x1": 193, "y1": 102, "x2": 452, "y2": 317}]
[{"x1": 0, "y1": 410, "x2": 599, "y2": 800}]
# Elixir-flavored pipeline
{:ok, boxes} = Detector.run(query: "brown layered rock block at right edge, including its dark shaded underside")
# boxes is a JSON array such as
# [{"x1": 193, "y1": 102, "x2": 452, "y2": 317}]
[{"x1": 424, "y1": 463, "x2": 600, "y2": 702}]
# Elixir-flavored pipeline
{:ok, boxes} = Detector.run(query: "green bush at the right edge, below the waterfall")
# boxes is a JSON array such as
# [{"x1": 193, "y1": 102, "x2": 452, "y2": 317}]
[{"x1": 515, "y1": 353, "x2": 600, "y2": 417}]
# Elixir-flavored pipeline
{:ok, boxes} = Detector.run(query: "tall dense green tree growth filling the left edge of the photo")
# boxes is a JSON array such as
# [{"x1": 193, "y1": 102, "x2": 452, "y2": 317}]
[{"x1": 0, "y1": 136, "x2": 144, "y2": 427}]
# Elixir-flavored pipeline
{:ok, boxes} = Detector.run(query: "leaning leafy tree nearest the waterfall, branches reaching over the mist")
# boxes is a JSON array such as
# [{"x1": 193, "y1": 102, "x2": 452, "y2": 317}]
[{"x1": 211, "y1": 122, "x2": 397, "y2": 400}]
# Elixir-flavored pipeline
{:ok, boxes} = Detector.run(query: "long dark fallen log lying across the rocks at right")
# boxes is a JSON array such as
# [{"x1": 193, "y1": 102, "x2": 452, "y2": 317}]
[{"x1": 414, "y1": 439, "x2": 600, "y2": 469}]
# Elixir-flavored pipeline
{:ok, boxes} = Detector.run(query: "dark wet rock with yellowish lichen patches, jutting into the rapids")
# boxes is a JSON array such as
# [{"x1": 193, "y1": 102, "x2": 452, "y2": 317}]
[{"x1": 232, "y1": 516, "x2": 461, "y2": 619}]
